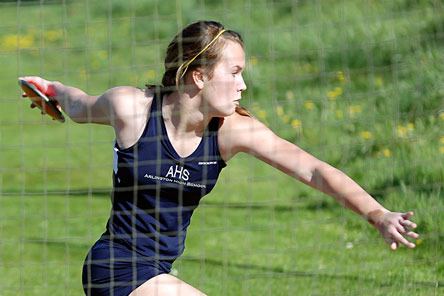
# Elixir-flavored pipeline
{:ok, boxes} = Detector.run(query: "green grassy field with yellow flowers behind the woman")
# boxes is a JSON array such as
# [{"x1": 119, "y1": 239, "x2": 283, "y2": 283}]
[{"x1": 0, "y1": 0, "x2": 444, "y2": 295}]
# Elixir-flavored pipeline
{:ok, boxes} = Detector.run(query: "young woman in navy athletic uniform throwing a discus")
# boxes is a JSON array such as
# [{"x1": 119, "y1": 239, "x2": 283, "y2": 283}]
[{"x1": 23, "y1": 21, "x2": 418, "y2": 295}]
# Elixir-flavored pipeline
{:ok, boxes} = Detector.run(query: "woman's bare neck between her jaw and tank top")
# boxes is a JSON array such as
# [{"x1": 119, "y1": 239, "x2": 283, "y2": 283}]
[{"x1": 162, "y1": 91, "x2": 211, "y2": 136}]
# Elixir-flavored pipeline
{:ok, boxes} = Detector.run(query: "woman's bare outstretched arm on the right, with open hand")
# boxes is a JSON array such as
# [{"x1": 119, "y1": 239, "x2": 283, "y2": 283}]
[{"x1": 222, "y1": 114, "x2": 418, "y2": 250}]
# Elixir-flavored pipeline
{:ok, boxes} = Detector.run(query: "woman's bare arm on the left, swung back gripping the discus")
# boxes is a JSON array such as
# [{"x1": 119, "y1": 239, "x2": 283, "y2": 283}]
[{"x1": 21, "y1": 76, "x2": 143, "y2": 128}]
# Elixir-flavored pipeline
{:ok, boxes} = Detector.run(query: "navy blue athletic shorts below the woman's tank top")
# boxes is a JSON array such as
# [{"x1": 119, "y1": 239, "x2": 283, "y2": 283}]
[{"x1": 82, "y1": 239, "x2": 171, "y2": 296}]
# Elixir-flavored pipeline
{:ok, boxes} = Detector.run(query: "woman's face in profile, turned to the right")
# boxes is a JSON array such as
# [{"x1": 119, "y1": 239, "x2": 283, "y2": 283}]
[{"x1": 202, "y1": 40, "x2": 247, "y2": 117}]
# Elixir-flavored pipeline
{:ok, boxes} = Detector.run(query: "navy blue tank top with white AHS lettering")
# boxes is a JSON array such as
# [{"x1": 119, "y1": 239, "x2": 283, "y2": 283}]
[{"x1": 103, "y1": 95, "x2": 226, "y2": 262}]
